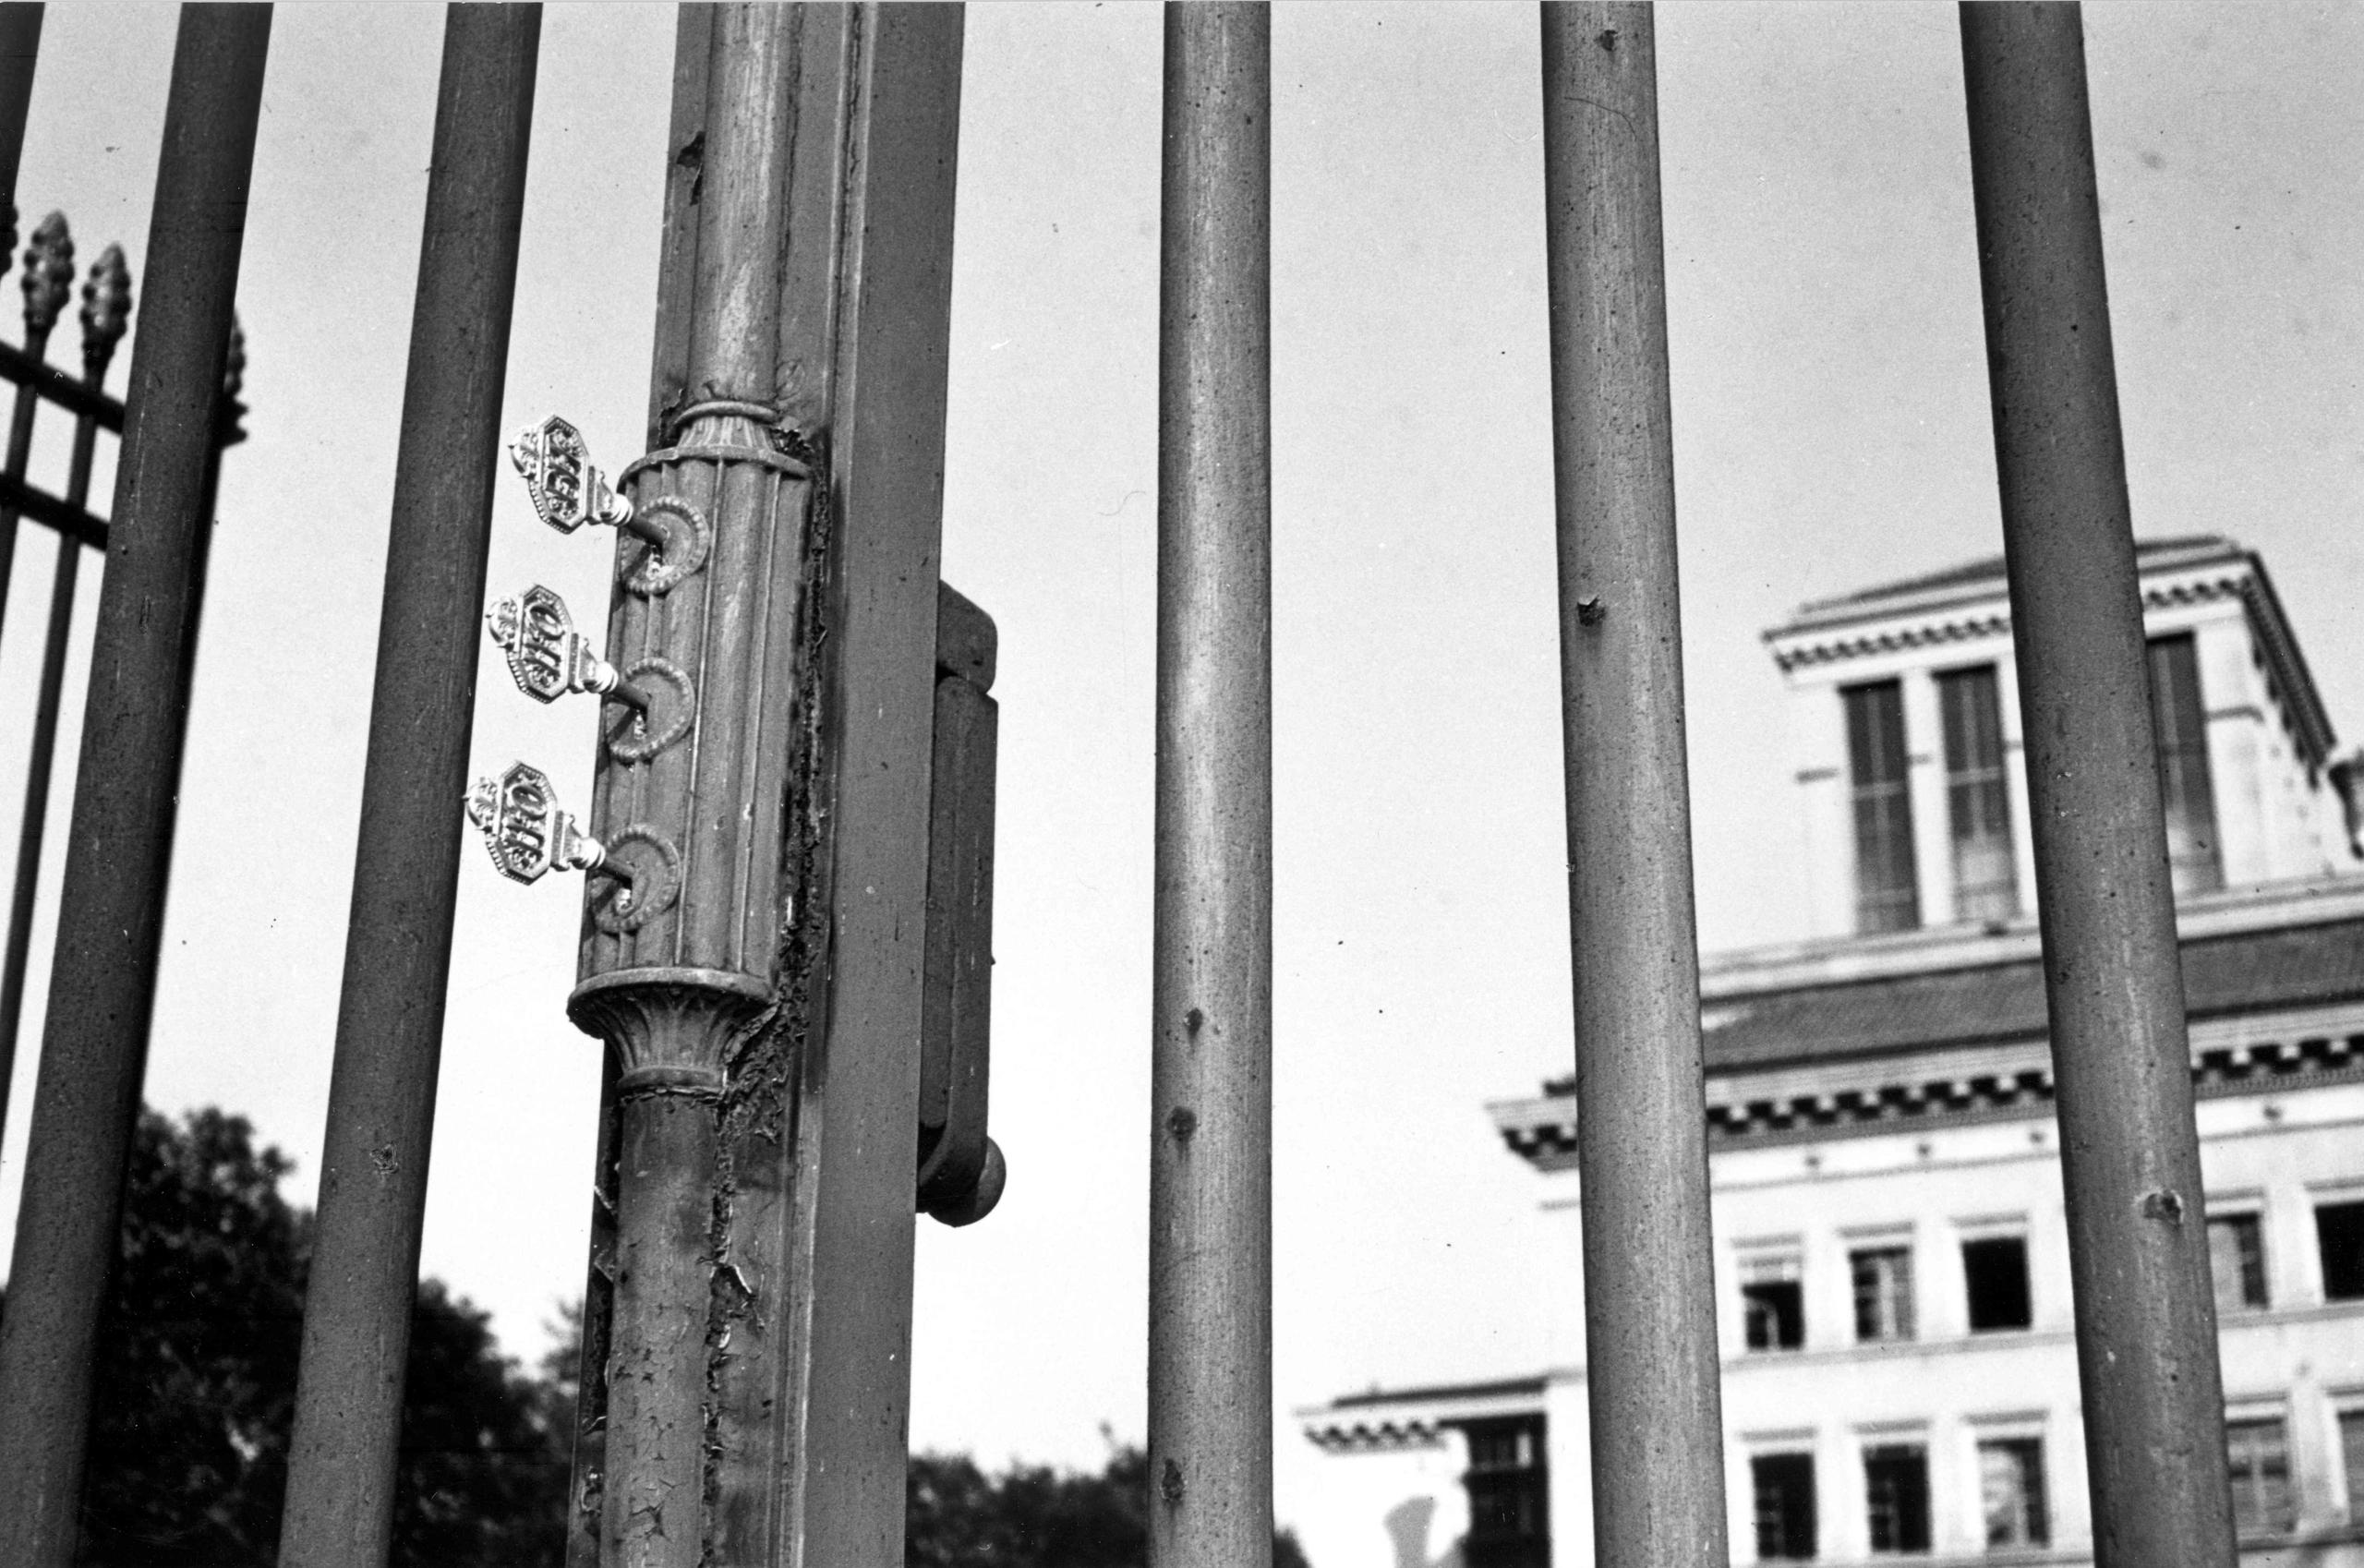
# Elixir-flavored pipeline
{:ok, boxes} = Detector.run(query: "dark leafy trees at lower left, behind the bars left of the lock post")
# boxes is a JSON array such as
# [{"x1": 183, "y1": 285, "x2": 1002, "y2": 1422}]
[{"x1": 66, "y1": 1109, "x2": 570, "y2": 1568}]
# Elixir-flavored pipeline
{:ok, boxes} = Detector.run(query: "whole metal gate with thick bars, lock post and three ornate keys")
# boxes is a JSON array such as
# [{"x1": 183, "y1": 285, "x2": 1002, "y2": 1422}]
[{"x1": 0, "y1": 3, "x2": 2232, "y2": 1568}]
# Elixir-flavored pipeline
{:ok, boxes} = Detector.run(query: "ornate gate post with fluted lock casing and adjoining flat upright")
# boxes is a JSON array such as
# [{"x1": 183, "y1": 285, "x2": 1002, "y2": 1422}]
[{"x1": 537, "y1": 5, "x2": 959, "y2": 1568}]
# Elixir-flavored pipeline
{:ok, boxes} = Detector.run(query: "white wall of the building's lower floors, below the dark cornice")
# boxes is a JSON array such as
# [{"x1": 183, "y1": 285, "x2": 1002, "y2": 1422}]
[{"x1": 1544, "y1": 1083, "x2": 2364, "y2": 1568}]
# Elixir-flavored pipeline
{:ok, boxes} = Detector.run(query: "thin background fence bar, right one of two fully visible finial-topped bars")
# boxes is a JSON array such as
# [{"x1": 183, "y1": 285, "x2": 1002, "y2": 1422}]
[{"x1": 0, "y1": 246, "x2": 132, "y2": 1153}]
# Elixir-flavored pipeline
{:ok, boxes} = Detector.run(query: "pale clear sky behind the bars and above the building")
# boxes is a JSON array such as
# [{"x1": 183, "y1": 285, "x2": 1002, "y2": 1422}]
[{"x1": 0, "y1": 3, "x2": 2364, "y2": 1518}]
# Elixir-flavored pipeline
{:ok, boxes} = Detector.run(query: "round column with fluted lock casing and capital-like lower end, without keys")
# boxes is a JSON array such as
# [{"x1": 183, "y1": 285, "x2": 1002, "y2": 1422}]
[{"x1": 570, "y1": 5, "x2": 814, "y2": 1568}]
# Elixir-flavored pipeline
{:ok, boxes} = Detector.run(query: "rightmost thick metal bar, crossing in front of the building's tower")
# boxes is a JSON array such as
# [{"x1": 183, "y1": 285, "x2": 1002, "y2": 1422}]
[{"x1": 1962, "y1": 5, "x2": 2234, "y2": 1568}]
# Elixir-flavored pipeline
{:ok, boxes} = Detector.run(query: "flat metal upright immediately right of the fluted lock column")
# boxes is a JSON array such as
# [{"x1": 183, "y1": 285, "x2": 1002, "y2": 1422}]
[{"x1": 780, "y1": 5, "x2": 964, "y2": 1568}]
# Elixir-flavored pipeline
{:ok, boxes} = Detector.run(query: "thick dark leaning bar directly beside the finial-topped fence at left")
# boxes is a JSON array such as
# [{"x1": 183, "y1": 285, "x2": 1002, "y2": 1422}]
[{"x1": 0, "y1": 5, "x2": 271, "y2": 1568}]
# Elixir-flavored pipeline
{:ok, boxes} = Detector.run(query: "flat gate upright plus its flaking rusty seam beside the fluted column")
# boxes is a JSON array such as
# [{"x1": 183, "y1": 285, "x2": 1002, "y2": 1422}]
[{"x1": 717, "y1": 5, "x2": 962, "y2": 1568}]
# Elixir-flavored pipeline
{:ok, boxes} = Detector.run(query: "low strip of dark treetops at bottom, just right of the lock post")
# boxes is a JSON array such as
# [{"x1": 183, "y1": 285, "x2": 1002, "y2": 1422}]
[{"x1": 903, "y1": 1447, "x2": 1308, "y2": 1568}]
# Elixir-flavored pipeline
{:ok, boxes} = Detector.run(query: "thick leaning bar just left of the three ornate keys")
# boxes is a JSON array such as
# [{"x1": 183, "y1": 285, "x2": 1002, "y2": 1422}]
[{"x1": 279, "y1": 5, "x2": 541, "y2": 1568}]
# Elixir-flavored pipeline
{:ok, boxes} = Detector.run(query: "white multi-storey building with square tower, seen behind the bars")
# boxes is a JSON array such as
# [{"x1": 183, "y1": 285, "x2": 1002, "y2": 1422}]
[{"x1": 1300, "y1": 539, "x2": 2364, "y2": 1568}]
